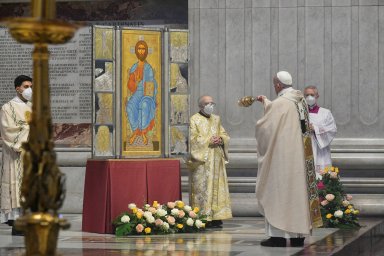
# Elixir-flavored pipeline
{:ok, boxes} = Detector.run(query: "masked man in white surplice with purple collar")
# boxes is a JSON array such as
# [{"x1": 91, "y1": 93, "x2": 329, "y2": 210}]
[{"x1": 304, "y1": 85, "x2": 337, "y2": 177}]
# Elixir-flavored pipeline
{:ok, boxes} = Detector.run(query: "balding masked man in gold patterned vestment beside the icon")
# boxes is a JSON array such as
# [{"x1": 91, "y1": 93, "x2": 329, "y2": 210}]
[{"x1": 187, "y1": 96, "x2": 232, "y2": 227}]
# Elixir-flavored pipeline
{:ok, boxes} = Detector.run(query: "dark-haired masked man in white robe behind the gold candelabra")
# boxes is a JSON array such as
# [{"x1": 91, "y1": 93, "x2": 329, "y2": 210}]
[{"x1": 0, "y1": 75, "x2": 32, "y2": 235}]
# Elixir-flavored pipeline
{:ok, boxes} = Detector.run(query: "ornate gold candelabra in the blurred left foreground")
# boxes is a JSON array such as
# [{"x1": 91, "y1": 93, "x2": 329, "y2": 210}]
[{"x1": 3, "y1": 0, "x2": 79, "y2": 255}]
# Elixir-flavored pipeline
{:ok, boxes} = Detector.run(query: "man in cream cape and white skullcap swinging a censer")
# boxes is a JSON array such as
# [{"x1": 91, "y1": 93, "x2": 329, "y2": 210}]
[{"x1": 250, "y1": 71, "x2": 322, "y2": 247}]
